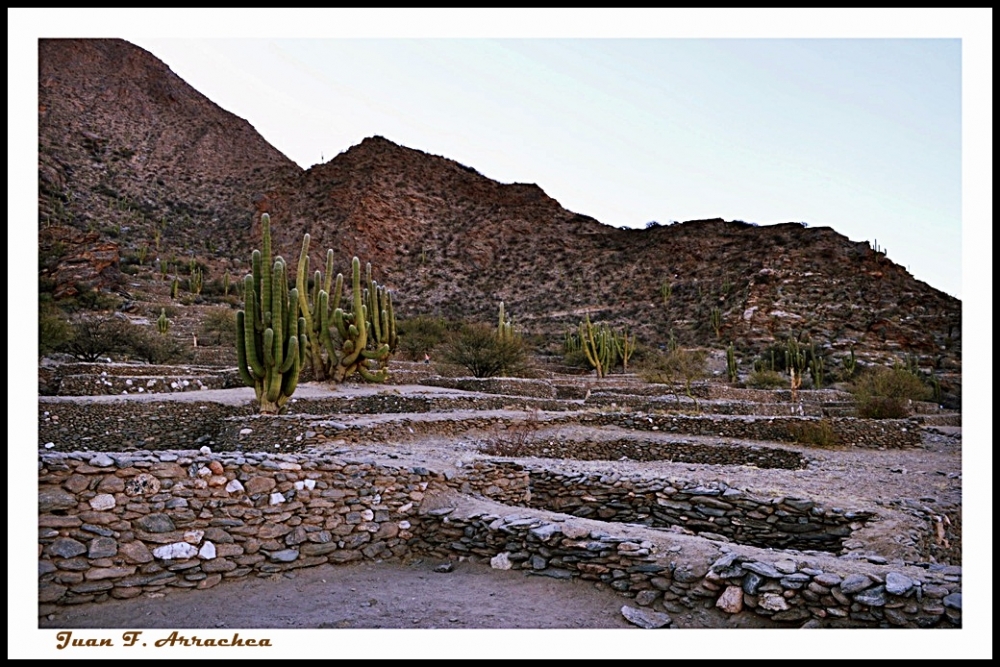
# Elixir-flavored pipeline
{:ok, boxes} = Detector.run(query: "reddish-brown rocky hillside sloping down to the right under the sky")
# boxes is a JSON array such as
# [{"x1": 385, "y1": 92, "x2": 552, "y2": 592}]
[{"x1": 39, "y1": 40, "x2": 961, "y2": 380}]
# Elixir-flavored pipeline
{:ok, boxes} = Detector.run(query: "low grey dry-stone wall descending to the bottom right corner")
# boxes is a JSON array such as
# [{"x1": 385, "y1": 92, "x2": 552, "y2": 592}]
[{"x1": 417, "y1": 510, "x2": 962, "y2": 628}]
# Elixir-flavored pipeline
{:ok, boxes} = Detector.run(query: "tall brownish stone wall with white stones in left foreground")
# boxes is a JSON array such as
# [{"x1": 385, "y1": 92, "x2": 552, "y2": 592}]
[{"x1": 38, "y1": 450, "x2": 443, "y2": 614}]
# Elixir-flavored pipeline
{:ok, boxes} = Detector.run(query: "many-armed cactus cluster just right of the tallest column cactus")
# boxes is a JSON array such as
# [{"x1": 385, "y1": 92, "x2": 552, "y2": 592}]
[{"x1": 295, "y1": 234, "x2": 399, "y2": 382}]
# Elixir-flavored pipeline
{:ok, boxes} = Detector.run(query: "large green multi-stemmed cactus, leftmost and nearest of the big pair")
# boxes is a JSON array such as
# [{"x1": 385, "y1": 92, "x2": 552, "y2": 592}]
[{"x1": 236, "y1": 213, "x2": 308, "y2": 414}]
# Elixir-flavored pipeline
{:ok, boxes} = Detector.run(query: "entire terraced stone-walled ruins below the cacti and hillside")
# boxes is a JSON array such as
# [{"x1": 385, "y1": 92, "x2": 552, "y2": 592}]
[{"x1": 38, "y1": 364, "x2": 962, "y2": 627}]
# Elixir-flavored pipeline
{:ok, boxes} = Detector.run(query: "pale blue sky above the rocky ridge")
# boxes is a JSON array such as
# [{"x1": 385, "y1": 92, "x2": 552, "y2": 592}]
[{"x1": 132, "y1": 37, "x2": 962, "y2": 296}]
